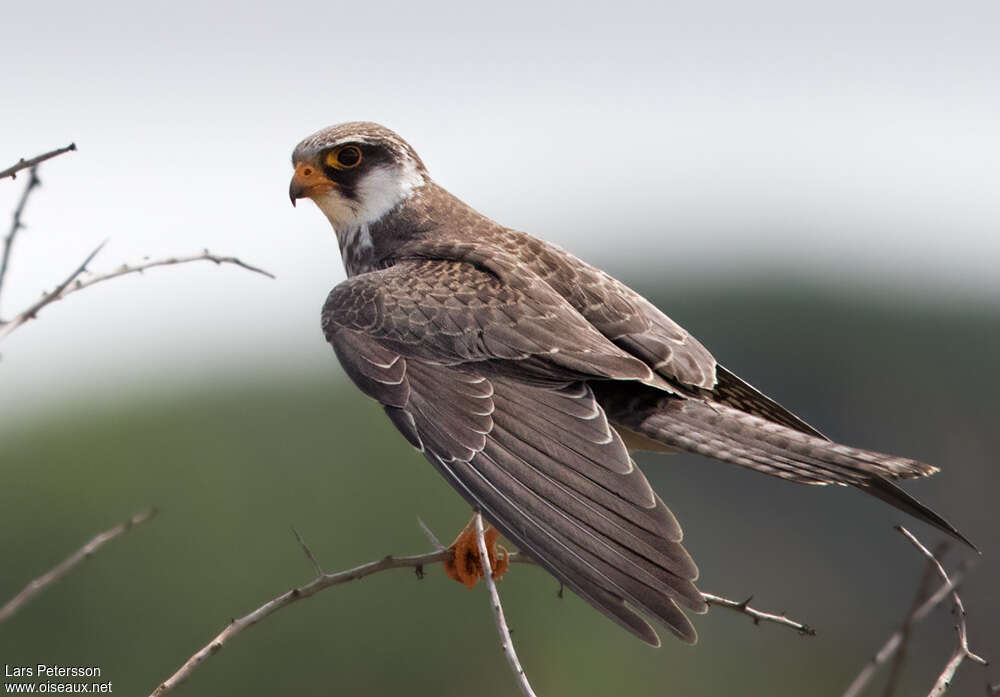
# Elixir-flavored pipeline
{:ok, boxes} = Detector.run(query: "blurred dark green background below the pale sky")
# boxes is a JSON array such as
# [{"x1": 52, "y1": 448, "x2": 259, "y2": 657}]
[{"x1": 0, "y1": 278, "x2": 1000, "y2": 697}]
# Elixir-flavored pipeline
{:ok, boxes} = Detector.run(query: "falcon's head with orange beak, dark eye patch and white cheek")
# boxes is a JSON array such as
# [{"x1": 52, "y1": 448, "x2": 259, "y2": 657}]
[{"x1": 288, "y1": 122, "x2": 428, "y2": 230}]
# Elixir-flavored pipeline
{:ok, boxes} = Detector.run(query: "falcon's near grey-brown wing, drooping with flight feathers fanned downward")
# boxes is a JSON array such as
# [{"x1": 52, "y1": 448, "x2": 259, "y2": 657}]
[{"x1": 324, "y1": 262, "x2": 706, "y2": 645}]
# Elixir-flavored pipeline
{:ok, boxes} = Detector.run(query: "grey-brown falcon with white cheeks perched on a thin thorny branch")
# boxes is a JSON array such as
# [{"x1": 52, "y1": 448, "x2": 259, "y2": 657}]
[{"x1": 289, "y1": 122, "x2": 964, "y2": 646}]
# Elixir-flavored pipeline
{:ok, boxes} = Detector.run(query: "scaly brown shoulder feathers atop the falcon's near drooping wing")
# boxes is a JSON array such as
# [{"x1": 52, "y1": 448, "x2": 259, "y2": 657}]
[{"x1": 323, "y1": 260, "x2": 654, "y2": 381}]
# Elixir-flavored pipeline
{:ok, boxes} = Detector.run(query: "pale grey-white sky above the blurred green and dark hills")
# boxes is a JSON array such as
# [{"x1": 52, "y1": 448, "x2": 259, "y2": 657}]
[{"x1": 0, "y1": 0, "x2": 1000, "y2": 422}]
